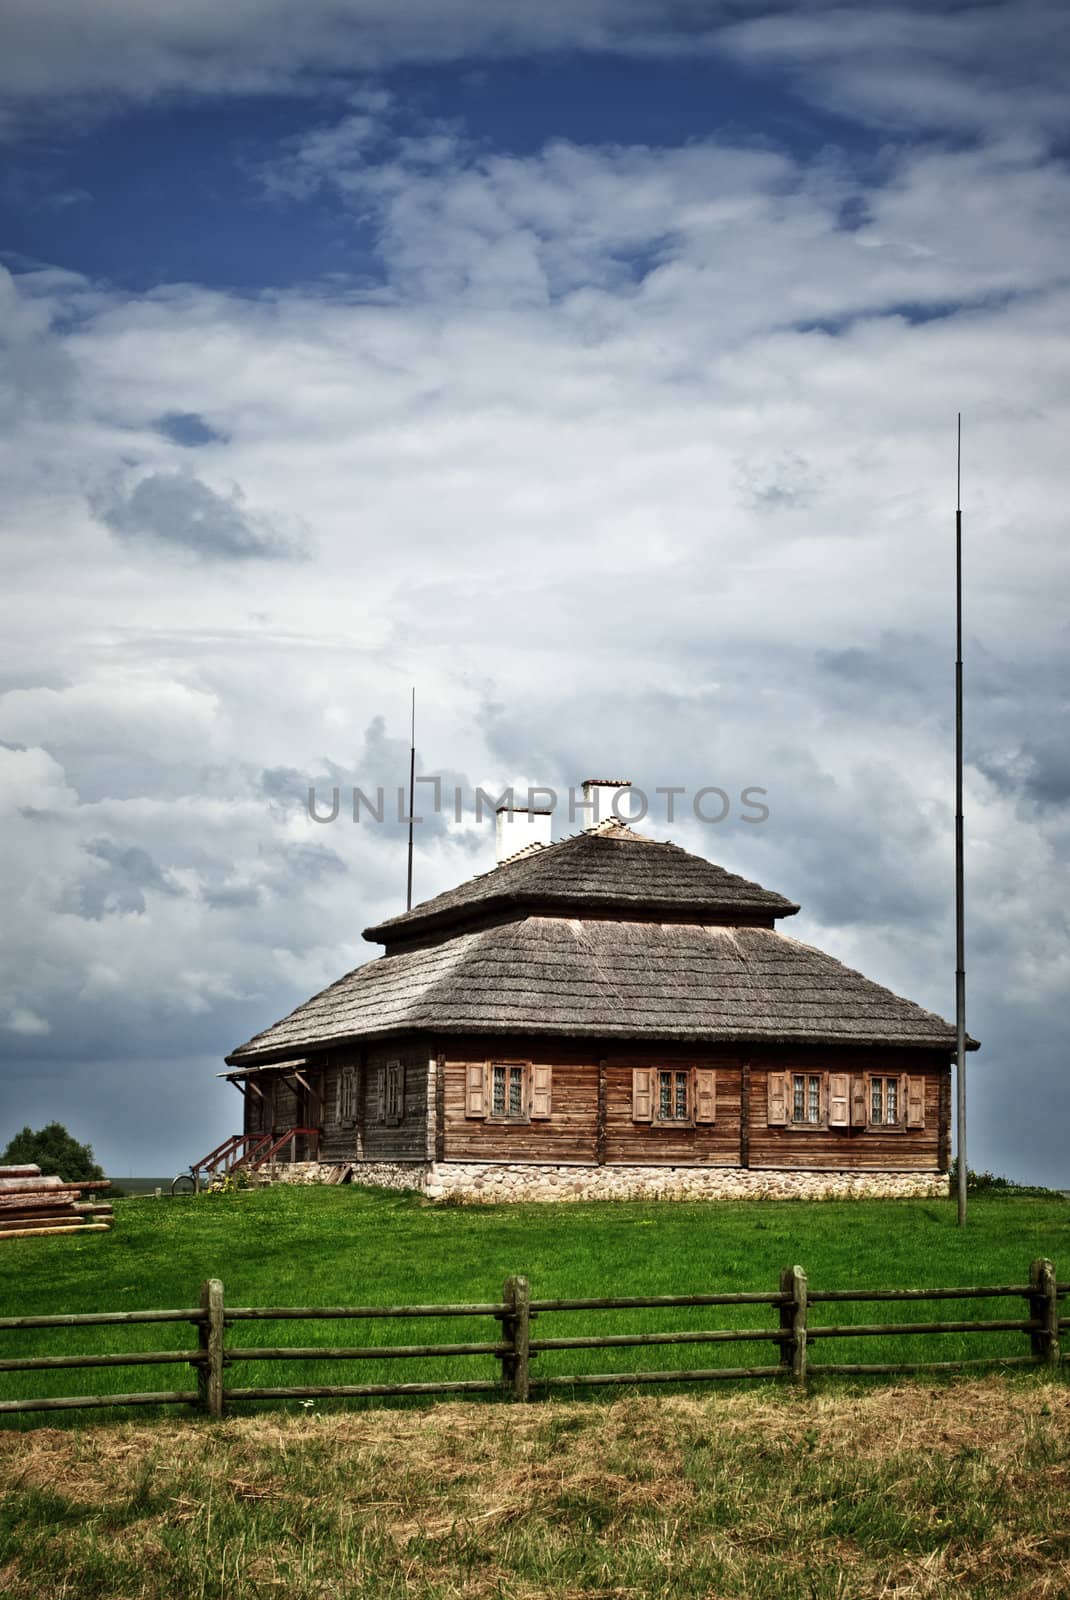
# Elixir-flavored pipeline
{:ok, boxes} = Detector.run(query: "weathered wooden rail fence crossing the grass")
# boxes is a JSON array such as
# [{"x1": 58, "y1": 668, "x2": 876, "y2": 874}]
[{"x1": 0, "y1": 1259, "x2": 1070, "y2": 1416}]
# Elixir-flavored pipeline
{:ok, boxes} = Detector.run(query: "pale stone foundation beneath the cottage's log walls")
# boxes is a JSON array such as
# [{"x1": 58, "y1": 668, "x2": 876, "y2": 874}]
[{"x1": 260, "y1": 1162, "x2": 948, "y2": 1203}]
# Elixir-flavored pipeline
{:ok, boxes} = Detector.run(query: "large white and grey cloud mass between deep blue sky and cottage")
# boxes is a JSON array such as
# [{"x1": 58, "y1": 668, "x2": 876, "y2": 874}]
[{"x1": 0, "y1": 106, "x2": 1070, "y2": 1176}]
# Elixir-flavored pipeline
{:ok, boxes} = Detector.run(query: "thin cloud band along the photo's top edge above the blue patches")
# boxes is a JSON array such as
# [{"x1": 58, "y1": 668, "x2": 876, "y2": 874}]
[{"x1": 0, "y1": 0, "x2": 1070, "y2": 154}]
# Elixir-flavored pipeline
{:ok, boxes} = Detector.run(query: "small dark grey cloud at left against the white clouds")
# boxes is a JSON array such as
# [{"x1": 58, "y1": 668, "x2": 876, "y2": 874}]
[{"x1": 91, "y1": 472, "x2": 302, "y2": 562}]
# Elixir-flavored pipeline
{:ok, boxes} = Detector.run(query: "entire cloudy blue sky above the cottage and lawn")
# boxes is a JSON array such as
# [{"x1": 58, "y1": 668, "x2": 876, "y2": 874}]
[{"x1": 0, "y1": 0, "x2": 1070, "y2": 1184}]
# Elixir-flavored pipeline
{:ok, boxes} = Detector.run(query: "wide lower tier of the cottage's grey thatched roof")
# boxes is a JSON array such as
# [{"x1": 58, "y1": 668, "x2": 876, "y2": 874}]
[{"x1": 227, "y1": 917, "x2": 955, "y2": 1066}]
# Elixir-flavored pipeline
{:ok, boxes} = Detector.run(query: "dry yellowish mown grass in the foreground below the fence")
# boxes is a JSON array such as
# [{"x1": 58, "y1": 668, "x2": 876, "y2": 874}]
[{"x1": 0, "y1": 1378, "x2": 1070, "y2": 1600}]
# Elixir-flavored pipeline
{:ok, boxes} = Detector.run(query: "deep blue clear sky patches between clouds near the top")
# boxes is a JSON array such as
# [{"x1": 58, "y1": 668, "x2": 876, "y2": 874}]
[{"x1": 0, "y1": 51, "x2": 857, "y2": 291}]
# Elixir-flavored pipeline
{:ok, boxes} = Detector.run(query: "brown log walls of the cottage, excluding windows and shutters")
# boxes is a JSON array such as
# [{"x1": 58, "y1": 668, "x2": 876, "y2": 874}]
[{"x1": 246, "y1": 1035, "x2": 950, "y2": 1173}]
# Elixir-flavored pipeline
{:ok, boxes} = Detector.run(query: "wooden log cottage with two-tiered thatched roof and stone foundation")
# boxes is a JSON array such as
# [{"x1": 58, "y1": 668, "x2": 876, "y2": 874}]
[{"x1": 226, "y1": 821, "x2": 972, "y2": 1200}]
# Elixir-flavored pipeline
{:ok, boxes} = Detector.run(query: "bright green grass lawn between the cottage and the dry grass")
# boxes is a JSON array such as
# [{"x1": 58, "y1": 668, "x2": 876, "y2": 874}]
[{"x1": 0, "y1": 1186, "x2": 1070, "y2": 1427}]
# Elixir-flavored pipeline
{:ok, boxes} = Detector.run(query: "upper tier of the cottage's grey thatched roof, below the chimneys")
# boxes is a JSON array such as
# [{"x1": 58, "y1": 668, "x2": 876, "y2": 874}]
[{"x1": 365, "y1": 821, "x2": 798, "y2": 944}]
